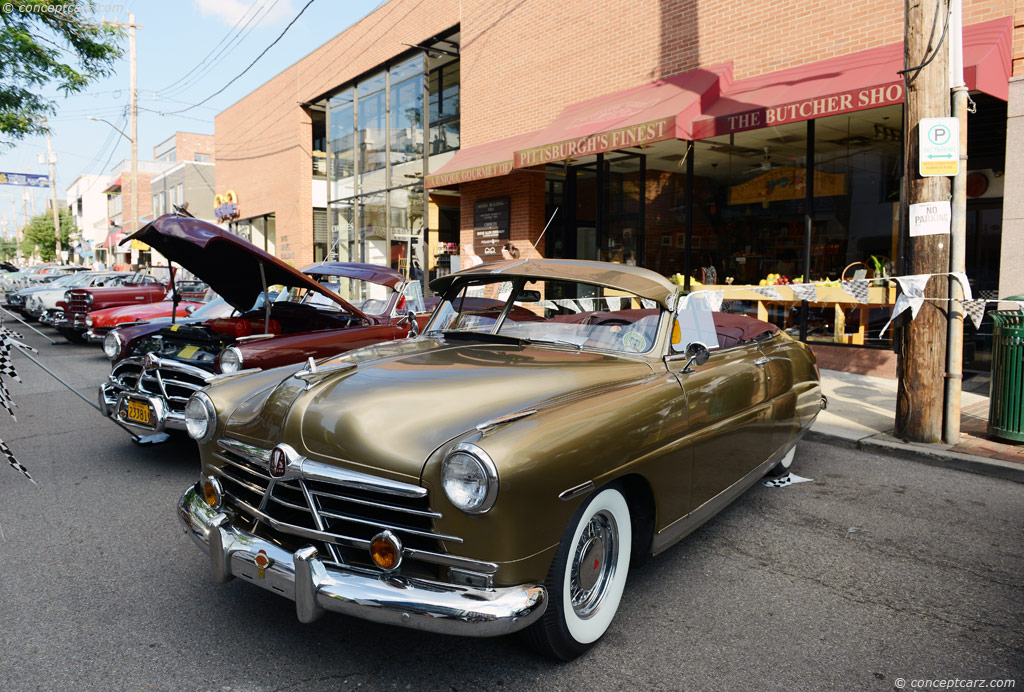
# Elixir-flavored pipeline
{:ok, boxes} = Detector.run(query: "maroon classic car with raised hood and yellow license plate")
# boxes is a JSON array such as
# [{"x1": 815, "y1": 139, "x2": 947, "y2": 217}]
[{"x1": 99, "y1": 214, "x2": 427, "y2": 433}]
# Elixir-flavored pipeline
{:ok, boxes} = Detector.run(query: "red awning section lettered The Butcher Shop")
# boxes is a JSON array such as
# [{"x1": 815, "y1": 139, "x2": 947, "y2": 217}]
[{"x1": 693, "y1": 16, "x2": 1013, "y2": 139}]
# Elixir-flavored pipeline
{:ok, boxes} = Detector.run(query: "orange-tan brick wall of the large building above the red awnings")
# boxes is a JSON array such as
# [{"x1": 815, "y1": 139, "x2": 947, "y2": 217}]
[{"x1": 215, "y1": 0, "x2": 1024, "y2": 266}]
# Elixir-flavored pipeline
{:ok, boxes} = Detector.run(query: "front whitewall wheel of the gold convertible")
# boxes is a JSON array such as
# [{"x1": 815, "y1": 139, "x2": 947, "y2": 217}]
[{"x1": 526, "y1": 486, "x2": 633, "y2": 660}]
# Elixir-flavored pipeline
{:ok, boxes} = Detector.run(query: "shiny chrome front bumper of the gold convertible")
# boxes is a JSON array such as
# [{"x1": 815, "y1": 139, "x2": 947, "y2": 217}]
[{"x1": 178, "y1": 487, "x2": 548, "y2": 637}]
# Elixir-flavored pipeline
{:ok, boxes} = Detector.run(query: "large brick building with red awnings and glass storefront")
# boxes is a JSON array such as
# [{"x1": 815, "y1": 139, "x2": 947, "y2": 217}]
[{"x1": 215, "y1": 0, "x2": 1024, "y2": 372}]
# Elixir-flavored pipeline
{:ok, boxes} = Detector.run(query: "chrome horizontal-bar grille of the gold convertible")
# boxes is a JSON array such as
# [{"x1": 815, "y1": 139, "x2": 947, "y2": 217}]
[{"x1": 213, "y1": 439, "x2": 481, "y2": 572}]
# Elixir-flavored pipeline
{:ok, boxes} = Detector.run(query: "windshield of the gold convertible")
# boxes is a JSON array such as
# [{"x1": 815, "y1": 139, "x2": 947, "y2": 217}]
[{"x1": 426, "y1": 278, "x2": 662, "y2": 353}]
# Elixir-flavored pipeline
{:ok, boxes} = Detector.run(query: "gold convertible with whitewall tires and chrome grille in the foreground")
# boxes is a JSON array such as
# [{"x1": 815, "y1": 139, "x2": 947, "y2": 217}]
[{"x1": 178, "y1": 259, "x2": 822, "y2": 659}]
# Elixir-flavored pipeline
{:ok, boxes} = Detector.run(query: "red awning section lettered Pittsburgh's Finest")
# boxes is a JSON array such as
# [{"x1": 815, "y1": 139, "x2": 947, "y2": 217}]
[{"x1": 513, "y1": 64, "x2": 732, "y2": 168}]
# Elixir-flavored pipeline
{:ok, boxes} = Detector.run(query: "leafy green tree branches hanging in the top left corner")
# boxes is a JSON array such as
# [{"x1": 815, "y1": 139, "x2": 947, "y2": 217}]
[{"x1": 0, "y1": 0, "x2": 123, "y2": 145}]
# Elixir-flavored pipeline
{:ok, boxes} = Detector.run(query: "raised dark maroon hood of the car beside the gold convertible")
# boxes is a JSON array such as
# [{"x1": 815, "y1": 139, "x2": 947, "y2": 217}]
[{"x1": 120, "y1": 214, "x2": 367, "y2": 319}]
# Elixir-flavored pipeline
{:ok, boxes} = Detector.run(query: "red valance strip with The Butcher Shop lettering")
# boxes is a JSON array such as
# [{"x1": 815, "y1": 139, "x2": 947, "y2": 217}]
[{"x1": 693, "y1": 82, "x2": 903, "y2": 139}]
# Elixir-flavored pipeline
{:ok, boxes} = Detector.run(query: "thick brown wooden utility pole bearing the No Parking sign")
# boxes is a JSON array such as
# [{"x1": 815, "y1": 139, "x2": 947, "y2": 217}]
[{"x1": 896, "y1": 0, "x2": 949, "y2": 442}]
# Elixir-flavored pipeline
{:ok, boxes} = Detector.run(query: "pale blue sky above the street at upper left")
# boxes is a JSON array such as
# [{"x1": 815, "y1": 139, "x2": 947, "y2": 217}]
[{"x1": 0, "y1": 0, "x2": 387, "y2": 235}]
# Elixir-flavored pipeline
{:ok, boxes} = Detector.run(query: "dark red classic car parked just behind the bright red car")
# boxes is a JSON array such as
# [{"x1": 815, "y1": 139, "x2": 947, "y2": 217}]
[{"x1": 54, "y1": 267, "x2": 199, "y2": 344}]
